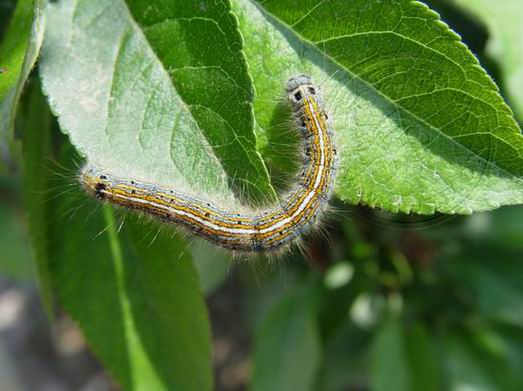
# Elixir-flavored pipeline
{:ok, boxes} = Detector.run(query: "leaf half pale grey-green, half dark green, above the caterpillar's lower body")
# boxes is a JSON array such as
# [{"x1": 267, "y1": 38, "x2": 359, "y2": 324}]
[{"x1": 40, "y1": 0, "x2": 276, "y2": 204}]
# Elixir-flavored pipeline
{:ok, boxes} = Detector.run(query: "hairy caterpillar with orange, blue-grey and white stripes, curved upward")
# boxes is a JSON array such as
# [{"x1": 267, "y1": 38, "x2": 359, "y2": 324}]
[{"x1": 80, "y1": 75, "x2": 337, "y2": 253}]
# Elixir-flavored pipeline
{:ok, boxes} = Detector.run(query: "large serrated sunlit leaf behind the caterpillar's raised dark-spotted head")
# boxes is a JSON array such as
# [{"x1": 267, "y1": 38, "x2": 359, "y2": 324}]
[{"x1": 233, "y1": 0, "x2": 523, "y2": 214}]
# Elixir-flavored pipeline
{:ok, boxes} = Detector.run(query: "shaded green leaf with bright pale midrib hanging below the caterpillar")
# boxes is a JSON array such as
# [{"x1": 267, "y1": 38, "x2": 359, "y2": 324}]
[{"x1": 49, "y1": 146, "x2": 212, "y2": 390}]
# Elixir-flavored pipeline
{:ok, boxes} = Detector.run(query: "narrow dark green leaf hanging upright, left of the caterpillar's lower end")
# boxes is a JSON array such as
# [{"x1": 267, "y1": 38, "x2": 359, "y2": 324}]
[{"x1": 21, "y1": 79, "x2": 53, "y2": 314}]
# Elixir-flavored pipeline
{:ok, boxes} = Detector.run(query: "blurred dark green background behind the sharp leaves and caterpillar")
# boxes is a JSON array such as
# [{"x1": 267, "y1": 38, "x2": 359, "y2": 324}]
[{"x1": 0, "y1": 0, "x2": 523, "y2": 391}]
